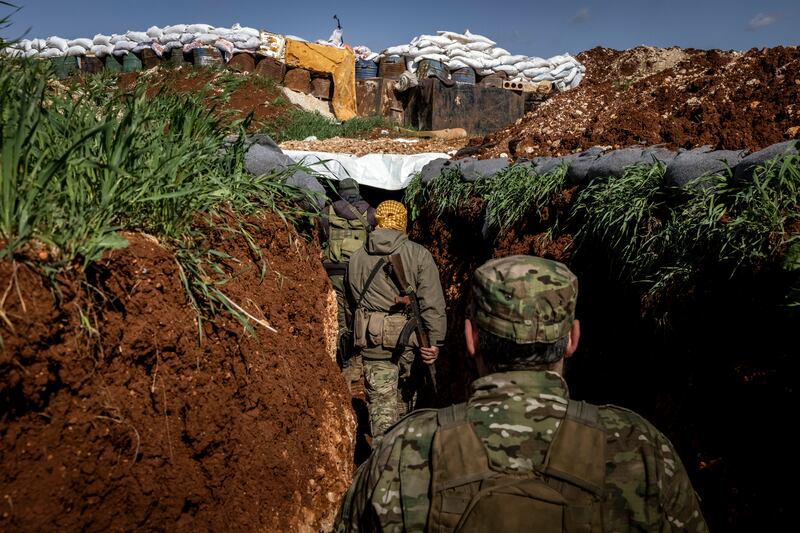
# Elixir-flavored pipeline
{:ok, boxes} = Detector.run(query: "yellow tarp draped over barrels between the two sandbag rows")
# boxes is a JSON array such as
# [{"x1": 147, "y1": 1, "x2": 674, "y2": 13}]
[{"x1": 284, "y1": 39, "x2": 356, "y2": 121}]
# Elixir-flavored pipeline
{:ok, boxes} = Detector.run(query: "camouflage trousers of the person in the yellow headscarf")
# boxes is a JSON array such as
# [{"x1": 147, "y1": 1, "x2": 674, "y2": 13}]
[{"x1": 363, "y1": 350, "x2": 418, "y2": 437}]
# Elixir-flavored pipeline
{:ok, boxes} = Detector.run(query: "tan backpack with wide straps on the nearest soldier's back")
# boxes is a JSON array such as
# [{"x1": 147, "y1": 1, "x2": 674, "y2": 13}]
[{"x1": 427, "y1": 400, "x2": 606, "y2": 533}]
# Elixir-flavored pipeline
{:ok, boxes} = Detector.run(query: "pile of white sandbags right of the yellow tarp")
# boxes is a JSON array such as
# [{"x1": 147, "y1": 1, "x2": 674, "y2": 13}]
[{"x1": 381, "y1": 30, "x2": 586, "y2": 91}]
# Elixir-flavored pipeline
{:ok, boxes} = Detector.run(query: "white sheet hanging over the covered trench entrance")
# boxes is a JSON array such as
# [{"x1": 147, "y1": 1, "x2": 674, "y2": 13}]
[{"x1": 283, "y1": 150, "x2": 450, "y2": 191}]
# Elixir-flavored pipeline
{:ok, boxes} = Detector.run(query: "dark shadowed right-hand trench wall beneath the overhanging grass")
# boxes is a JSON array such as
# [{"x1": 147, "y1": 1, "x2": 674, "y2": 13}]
[{"x1": 357, "y1": 184, "x2": 800, "y2": 531}]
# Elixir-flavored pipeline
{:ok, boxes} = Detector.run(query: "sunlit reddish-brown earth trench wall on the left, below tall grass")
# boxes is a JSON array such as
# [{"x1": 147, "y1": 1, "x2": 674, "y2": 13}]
[{"x1": 0, "y1": 215, "x2": 354, "y2": 531}]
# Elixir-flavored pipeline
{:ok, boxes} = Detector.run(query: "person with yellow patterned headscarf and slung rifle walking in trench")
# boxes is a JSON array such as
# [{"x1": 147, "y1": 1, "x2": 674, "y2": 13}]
[{"x1": 348, "y1": 200, "x2": 447, "y2": 436}]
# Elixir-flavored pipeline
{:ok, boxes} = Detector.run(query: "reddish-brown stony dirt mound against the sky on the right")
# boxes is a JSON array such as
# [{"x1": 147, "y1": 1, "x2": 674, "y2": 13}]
[{"x1": 471, "y1": 47, "x2": 800, "y2": 158}]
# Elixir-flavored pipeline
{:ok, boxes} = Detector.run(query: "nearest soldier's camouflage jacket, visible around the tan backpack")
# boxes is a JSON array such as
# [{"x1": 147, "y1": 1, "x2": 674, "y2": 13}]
[{"x1": 334, "y1": 371, "x2": 707, "y2": 532}]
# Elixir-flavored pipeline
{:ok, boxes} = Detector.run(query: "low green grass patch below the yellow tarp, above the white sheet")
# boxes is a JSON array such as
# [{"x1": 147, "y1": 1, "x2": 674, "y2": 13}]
[{"x1": 261, "y1": 109, "x2": 387, "y2": 143}]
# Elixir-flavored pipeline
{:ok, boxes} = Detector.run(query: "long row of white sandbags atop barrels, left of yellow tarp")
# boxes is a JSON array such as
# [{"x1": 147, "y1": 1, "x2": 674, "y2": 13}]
[{"x1": 3, "y1": 24, "x2": 261, "y2": 59}]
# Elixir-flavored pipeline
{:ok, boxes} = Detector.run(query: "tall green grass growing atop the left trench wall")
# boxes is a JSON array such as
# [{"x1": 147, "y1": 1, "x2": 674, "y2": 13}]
[{"x1": 0, "y1": 55, "x2": 314, "y2": 336}]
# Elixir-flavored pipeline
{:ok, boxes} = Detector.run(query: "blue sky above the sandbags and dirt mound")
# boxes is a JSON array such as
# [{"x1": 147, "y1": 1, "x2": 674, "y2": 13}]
[{"x1": 0, "y1": 0, "x2": 800, "y2": 57}]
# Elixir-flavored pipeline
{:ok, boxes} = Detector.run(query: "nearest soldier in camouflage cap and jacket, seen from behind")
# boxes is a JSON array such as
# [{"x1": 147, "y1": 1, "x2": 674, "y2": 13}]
[{"x1": 334, "y1": 256, "x2": 707, "y2": 532}]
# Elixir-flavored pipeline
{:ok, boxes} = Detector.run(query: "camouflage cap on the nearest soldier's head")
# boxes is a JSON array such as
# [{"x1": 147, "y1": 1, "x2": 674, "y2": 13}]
[{"x1": 472, "y1": 255, "x2": 578, "y2": 344}]
